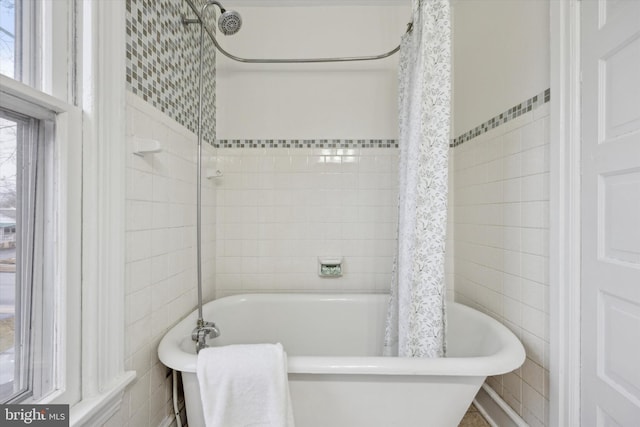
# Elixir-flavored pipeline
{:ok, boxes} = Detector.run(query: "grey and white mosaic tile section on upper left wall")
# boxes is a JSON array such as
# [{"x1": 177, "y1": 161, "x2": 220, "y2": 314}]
[{"x1": 126, "y1": 0, "x2": 216, "y2": 143}]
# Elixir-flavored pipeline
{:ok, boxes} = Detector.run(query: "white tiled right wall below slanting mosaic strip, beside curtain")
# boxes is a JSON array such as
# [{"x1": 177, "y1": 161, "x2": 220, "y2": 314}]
[{"x1": 453, "y1": 103, "x2": 549, "y2": 427}]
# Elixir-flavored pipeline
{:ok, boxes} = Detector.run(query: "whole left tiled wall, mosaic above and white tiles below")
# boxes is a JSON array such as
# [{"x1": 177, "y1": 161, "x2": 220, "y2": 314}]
[{"x1": 117, "y1": 0, "x2": 216, "y2": 427}]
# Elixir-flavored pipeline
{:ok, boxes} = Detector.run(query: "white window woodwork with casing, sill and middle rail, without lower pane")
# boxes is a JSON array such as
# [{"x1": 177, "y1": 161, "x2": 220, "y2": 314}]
[{"x1": 0, "y1": 0, "x2": 135, "y2": 426}]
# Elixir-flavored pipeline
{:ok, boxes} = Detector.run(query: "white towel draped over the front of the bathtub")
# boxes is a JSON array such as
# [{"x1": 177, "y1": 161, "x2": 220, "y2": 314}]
[{"x1": 197, "y1": 343, "x2": 293, "y2": 427}]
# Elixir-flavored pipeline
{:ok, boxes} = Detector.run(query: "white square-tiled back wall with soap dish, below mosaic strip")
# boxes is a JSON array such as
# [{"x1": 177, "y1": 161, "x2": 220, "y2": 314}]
[{"x1": 215, "y1": 145, "x2": 398, "y2": 296}]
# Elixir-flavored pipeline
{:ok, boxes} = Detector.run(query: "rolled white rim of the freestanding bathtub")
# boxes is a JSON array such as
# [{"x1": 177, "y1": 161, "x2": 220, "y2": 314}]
[{"x1": 158, "y1": 293, "x2": 525, "y2": 376}]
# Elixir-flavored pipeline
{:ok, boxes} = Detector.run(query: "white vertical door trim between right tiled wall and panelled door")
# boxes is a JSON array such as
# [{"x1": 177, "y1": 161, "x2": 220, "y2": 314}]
[{"x1": 549, "y1": 0, "x2": 581, "y2": 427}]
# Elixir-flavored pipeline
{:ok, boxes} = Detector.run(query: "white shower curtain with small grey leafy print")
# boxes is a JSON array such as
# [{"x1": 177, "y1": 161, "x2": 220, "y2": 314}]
[{"x1": 384, "y1": 0, "x2": 451, "y2": 357}]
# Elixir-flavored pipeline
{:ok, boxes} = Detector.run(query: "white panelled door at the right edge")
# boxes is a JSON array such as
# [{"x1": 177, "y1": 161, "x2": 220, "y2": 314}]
[{"x1": 580, "y1": 0, "x2": 640, "y2": 427}]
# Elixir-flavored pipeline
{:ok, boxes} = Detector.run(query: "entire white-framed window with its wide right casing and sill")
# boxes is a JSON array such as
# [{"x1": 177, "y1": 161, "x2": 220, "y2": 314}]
[{"x1": 0, "y1": 0, "x2": 135, "y2": 425}]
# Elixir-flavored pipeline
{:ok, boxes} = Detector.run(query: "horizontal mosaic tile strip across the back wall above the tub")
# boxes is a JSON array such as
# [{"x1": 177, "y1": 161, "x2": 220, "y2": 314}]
[{"x1": 214, "y1": 139, "x2": 398, "y2": 148}]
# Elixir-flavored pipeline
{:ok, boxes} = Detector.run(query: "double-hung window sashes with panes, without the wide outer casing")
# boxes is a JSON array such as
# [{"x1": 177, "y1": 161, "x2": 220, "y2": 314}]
[{"x1": 0, "y1": 0, "x2": 82, "y2": 403}]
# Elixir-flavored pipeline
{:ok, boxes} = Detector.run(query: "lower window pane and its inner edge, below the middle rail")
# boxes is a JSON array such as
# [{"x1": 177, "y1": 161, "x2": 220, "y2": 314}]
[{"x1": 0, "y1": 102, "x2": 55, "y2": 403}]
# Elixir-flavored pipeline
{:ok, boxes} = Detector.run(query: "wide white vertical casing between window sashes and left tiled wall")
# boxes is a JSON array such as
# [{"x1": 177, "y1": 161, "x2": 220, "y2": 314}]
[{"x1": 71, "y1": 0, "x2": 135, "y2": 426}]
